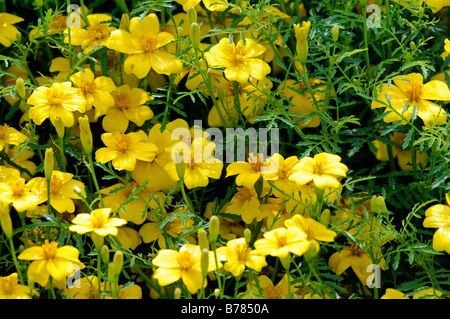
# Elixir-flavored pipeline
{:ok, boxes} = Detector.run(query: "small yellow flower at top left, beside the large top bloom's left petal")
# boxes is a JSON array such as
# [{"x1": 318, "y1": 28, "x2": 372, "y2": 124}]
[{"x1": 64, "y1": 13, "x2": 116, "y2": 54}]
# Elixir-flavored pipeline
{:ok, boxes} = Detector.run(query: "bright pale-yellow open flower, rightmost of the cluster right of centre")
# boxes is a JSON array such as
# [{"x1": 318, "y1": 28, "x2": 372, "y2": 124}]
[{"x1": 289, "y1": 153, "x2": 348, "y2": 189}]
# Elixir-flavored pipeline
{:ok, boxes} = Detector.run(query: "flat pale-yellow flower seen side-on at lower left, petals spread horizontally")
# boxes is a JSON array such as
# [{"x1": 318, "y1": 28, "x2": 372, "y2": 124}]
[{"x1": 69, "y1": 208, "x2": 127, "y2": 237}]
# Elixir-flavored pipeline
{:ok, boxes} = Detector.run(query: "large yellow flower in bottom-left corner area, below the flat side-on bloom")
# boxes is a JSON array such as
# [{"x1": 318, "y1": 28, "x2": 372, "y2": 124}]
[{"x1": 17, "y1": 240, "x2": 85, "y2": 287}]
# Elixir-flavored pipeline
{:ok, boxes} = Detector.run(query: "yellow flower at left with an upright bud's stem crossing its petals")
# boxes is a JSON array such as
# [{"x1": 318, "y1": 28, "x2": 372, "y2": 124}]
[{"x1": 27, "y1": 170, "x2": 86, "y2": 213}]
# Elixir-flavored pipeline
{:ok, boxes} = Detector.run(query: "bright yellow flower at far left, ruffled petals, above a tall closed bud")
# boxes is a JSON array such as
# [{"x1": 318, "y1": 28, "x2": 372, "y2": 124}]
[{"x1": 27, "y1": 82, "x2": 86, "y2": 127}]
